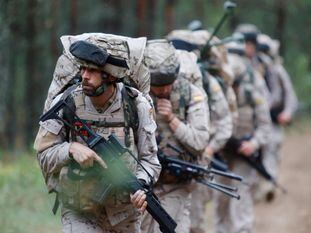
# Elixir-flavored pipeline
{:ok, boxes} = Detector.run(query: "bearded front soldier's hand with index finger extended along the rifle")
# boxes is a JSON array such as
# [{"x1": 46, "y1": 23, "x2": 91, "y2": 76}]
[{"x1": 69, "y1": 142, "x2": 107, "y2": 168}]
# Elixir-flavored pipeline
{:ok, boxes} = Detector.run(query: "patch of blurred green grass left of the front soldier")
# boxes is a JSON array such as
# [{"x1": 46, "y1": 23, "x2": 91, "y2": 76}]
[{"x1": 0, "y1": 154, "x2": 60, "y2": 233}]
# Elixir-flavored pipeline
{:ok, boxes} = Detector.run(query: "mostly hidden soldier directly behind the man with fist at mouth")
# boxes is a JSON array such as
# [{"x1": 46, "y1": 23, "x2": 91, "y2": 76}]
[{"x1": 168, "y1": 30, "x2": 233, "y2": 233}]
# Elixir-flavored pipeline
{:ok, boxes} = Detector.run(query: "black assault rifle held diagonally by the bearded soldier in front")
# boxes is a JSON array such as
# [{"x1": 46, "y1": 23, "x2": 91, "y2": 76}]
[{"x1": 40, "y1": 89, "x2": 177, "y2": 233}]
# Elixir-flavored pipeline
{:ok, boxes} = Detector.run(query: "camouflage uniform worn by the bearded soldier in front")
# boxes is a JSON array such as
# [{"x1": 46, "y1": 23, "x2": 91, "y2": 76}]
[{"x1": 34, "y1": 37, "x2": 161, "y2": 233}]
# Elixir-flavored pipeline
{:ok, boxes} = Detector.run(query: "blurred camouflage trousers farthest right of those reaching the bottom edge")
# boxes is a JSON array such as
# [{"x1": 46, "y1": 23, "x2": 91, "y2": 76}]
[{"x1": 213, "y1": 160, "x2": 258, "y2": 233}]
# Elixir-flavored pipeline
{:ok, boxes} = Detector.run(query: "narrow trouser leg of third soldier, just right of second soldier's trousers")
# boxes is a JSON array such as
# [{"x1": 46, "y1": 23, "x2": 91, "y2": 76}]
[{"x1": 190, "y1": 184, "x2": 212, "y2": 233}]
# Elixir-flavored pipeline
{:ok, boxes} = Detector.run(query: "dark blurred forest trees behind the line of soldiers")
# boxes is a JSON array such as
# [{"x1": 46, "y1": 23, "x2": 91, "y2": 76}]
[{"x1": 0, "y1": 0, "x2": 311, "y2": 150}]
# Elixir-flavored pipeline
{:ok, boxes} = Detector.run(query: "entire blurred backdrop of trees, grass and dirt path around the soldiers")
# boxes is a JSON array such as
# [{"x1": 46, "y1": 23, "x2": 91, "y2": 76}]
[{"x1": 0, "y1": 0, "x2": 311, "y2": 233}]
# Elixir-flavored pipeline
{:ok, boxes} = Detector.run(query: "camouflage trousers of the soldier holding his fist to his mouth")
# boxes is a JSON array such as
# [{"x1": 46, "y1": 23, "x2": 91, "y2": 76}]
[{"x1": 141, "y1": 185, "x2": 191, "y2": 233}]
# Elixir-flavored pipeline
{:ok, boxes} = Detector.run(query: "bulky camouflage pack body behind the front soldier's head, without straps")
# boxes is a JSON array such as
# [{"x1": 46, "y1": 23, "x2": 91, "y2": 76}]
[{"x1": 44, "y1": 33, "x2": 150, "y2": 112}]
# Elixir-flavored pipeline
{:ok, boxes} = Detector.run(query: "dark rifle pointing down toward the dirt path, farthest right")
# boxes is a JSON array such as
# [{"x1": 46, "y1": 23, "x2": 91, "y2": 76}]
[{"x1": 224, "y1": 137, "x2": 287, "y2": 193}]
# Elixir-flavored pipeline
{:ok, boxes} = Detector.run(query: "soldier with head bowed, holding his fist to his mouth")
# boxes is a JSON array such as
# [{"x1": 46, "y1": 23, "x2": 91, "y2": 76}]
[{"x1": 142, "y1": 40, "x2": 209, "y2": 233}]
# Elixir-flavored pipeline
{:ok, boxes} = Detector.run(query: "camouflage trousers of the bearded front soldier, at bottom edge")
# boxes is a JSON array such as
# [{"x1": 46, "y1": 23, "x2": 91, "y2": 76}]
[{"x1": 62, "y1": 204, "x2": 141, "y2": 233}]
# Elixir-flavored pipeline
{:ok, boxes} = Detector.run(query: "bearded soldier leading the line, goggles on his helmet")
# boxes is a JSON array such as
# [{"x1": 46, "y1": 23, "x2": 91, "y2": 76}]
[{"x1": 34, "y1": 39, "x2": 161, "y2": 233}]
